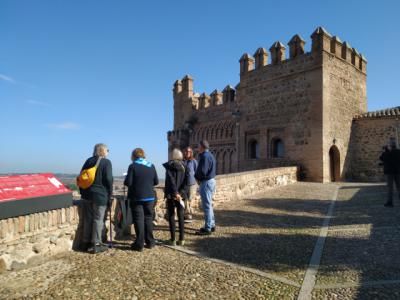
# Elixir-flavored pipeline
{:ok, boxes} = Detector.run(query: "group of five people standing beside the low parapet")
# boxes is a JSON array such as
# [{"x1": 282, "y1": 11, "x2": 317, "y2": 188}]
[{"x1": 80, "y1": 140, "x2": 216, "y2": 253}]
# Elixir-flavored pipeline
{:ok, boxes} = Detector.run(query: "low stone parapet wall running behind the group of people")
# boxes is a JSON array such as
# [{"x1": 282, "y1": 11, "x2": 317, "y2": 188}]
[{"x1": 0, "y1": 167, "x2": 297, "y2": 272}]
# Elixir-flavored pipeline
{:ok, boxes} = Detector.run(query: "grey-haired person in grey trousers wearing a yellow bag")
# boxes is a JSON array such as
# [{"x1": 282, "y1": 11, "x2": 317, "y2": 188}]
[{"x1": 80, "y1": 144, "x2": 113, "y2": 253}]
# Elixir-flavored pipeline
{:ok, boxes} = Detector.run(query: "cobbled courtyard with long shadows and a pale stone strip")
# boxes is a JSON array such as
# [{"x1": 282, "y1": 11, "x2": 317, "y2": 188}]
[{"x1": 0, "y1": 183, "x2": 400, "y2": 299}]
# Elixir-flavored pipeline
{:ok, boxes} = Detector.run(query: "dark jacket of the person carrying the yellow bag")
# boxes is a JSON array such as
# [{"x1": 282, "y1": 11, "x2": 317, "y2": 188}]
[{"x1": 80, "y1": 156, "x2": 113, "y2": 206}]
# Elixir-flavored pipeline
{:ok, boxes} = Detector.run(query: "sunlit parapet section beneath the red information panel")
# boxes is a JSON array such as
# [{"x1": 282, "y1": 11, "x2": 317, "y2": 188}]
[{"x1": 0, "y1": 206, "x2": 79, "y2": 272}]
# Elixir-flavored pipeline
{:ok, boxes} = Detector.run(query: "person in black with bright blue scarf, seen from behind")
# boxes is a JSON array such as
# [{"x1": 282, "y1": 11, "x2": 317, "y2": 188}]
[{"x1": 124, "y1": 148, "x2": 158, "y2": 251}]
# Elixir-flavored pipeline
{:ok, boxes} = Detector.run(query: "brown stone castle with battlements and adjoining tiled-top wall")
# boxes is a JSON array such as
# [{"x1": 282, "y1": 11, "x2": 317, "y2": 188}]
[{"x1": 168, "y1": 27, "x2": 400, "y2": 182}]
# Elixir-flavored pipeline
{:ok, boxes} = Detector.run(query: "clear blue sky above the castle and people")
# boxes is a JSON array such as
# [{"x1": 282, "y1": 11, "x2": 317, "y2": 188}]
[{"x1": 0, "y1": 0, "x2": 400, "y2": 175}]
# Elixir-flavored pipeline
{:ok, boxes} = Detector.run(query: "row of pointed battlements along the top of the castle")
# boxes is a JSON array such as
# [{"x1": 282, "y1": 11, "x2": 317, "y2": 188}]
[{"x1": 173, "y1": 27, "x2": 367, "y2": 118}]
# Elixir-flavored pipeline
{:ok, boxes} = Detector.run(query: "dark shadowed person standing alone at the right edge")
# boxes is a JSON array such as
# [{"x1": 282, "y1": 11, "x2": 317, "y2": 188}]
[{"x1": 379, "y1": 138, "x2": 400, "y2": 207}]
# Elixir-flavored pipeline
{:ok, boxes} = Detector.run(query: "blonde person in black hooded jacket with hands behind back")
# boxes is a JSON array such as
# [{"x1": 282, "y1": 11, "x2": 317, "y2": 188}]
[{"x1": 163, "y1": 149, "x2": 186, "y2": 246}]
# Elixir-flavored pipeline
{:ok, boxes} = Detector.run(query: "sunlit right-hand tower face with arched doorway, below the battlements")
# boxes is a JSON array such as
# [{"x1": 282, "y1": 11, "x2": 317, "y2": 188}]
[{"x1": 323, "y1": 48, "x2": 367, "y2": 181}]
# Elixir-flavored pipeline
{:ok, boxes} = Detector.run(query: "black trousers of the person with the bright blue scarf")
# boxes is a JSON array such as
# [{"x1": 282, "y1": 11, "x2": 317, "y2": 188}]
[{"x1": 131, "y1": 201, "x2": 155, "y2": 248}]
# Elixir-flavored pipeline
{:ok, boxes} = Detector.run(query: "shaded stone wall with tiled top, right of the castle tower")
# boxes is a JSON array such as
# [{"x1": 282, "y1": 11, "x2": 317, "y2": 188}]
[{"x1": 346, "y1": 116, "x2": 400, "y2": 181}]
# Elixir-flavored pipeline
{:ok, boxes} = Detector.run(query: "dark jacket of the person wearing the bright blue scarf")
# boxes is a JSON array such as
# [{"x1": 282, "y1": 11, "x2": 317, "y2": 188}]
[{"x1": 124, "y1": 159, "x2": 158, "y2": 201}]
